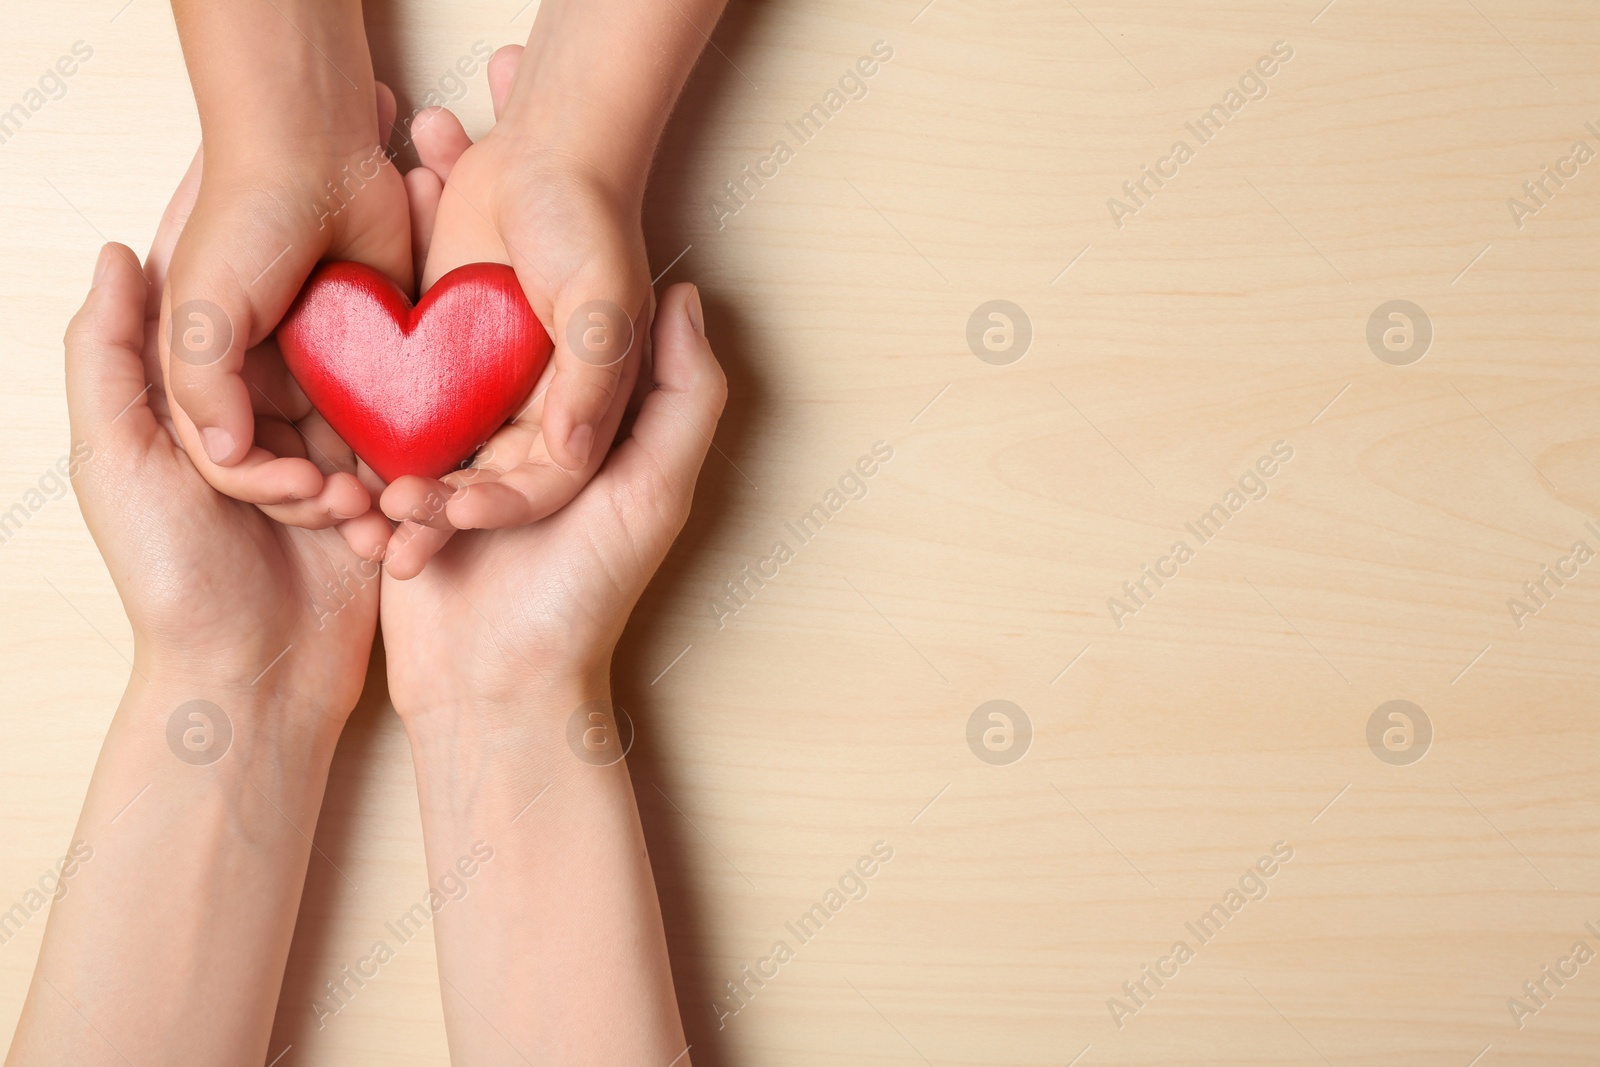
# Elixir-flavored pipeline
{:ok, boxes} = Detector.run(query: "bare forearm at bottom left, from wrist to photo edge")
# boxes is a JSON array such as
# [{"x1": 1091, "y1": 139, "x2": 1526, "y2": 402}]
[{"x1": 6, "y1": 677, "x2": 338, "y2": 1067}]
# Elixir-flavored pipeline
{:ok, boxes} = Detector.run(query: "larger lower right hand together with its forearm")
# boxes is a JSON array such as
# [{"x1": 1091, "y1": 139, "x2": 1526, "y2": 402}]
[{"x1": 379, "y1": 99, "x2": 726, "y2": 1065}]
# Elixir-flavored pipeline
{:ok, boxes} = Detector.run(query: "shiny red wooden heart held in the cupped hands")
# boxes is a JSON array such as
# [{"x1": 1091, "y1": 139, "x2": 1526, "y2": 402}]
[{"x1": 278, "y1": 262, "x2": 552, "y2": 482}]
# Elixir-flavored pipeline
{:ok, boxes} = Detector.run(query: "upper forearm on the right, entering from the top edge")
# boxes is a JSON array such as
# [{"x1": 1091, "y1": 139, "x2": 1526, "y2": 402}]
[{"x1": 501, "y1": 0, "x2": 726, "y2": 198}]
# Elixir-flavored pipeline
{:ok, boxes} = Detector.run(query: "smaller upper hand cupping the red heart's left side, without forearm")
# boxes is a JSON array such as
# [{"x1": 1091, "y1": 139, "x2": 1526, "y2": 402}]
[{"x1": 155, "y1": 83, "x2": 413, "y2": 528}]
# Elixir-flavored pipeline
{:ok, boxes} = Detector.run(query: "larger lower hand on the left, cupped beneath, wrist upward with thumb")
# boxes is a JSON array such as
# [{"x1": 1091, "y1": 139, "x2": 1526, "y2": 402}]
[{"x1": 66, "y1": 157, "x2": 389, "y2": 725}]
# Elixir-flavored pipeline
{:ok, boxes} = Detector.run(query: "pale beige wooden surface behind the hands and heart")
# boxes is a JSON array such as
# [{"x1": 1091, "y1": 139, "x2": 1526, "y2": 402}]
[{"x1": 0, "y1": 0, "x2": 1600, "y2": 1067}]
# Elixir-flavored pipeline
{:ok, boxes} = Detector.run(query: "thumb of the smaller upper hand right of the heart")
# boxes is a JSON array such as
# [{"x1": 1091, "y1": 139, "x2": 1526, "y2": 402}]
[{"x1": 537, "y1": 246, "x2": 650, "y2": 470}]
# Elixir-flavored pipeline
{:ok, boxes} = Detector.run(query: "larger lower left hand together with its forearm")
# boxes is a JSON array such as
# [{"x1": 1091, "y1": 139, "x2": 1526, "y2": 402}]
[{"x1": 6, "y1": 150, "x2": 389, "y2": 1067}]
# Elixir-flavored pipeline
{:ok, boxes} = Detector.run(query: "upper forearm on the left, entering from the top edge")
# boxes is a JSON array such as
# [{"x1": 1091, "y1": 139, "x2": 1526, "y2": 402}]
[{"x1": 173, "y1": 0, "x2": 374, "y2": 155}]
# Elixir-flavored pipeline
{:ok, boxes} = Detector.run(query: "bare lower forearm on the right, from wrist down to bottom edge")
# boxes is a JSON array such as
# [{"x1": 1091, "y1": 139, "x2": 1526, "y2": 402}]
[{"x1": 408, "y1": 685, "x2": 688, "y2": 1067}]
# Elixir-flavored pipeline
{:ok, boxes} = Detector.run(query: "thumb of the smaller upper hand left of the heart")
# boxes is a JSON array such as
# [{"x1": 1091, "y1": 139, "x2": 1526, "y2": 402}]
[{"x1": 158, "y1": 195, "x2": 330, "y2": 466}]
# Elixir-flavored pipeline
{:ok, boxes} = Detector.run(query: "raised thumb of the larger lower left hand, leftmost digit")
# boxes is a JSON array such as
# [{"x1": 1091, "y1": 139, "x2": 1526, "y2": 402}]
[{"x1": 66, "y1": 245, "x2": 162, "y2": 458}]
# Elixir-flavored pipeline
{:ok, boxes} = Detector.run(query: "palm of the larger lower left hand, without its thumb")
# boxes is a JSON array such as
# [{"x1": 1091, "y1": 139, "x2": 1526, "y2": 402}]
[{"x1": 78, "y1": 271, "x2": 378, "y2": 707}]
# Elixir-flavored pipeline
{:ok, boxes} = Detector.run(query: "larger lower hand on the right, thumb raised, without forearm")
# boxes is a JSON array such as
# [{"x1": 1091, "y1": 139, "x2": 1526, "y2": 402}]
[{"x1": 381, "y1": 283, "x2": 728, "y2": 720}]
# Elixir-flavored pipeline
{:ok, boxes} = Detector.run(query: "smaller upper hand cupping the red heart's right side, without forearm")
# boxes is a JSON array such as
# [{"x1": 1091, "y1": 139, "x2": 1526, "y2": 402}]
[{"x1": 381, "y1": 46, "x2": 654, "y2": 576}]
